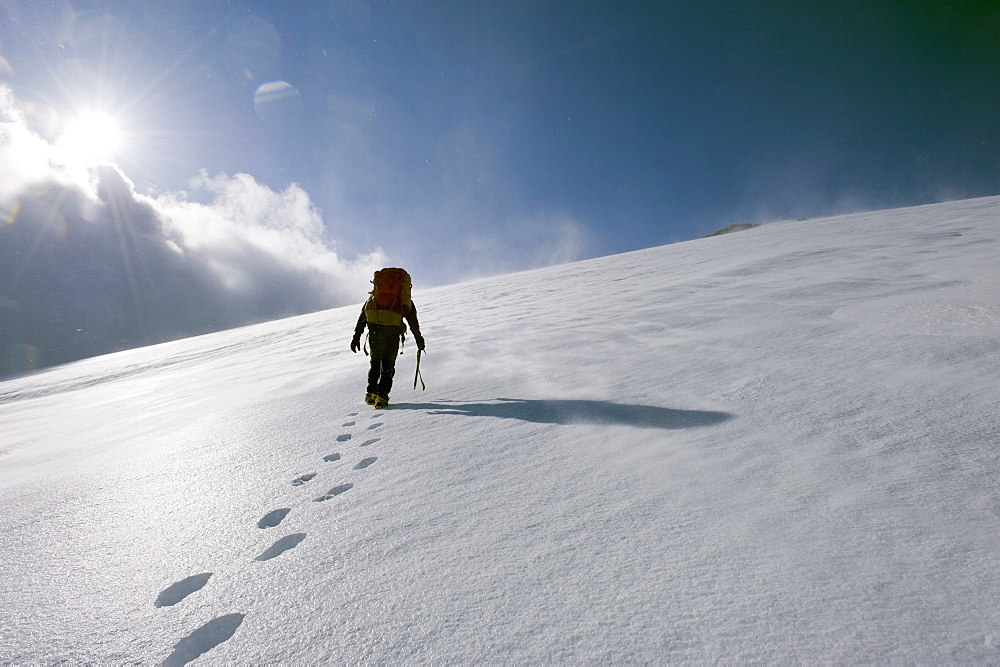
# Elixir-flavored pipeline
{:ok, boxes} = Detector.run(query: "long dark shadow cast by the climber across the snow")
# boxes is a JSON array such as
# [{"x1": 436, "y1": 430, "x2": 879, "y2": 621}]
[{"x1": 392, "y1": 398, "x2": 733, "y2": 429}]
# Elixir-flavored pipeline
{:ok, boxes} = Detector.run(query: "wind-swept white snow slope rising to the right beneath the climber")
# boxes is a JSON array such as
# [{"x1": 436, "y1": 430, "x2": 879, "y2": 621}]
[{"x1": 0, "y1": 198, "x2": 1000, "y2": 664}]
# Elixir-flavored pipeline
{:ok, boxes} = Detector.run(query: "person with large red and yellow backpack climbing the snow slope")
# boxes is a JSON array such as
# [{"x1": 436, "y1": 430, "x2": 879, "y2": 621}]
[{"x1": 351, "y1": 268, "x2": 424, "y2": 410}]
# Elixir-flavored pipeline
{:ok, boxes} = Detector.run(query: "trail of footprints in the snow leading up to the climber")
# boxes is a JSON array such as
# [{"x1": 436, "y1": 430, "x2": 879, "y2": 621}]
[{"x1": 153, "y1": 412, "x2": 385, "y2": 665}]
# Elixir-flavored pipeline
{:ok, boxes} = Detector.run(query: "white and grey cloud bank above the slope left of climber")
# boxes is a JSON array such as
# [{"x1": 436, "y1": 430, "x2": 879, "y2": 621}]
[{"x1": 0, "y1": 86, "x2": 385, "y2": 374}]
